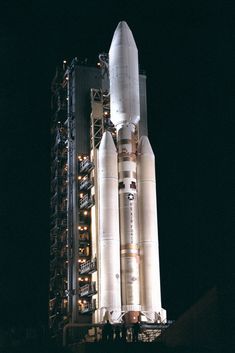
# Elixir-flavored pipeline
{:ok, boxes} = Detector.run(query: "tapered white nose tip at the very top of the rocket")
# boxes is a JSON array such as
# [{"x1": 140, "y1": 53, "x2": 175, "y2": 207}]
[{"x1": 110, "y1": 21, "x2": 136, "y2": 48}]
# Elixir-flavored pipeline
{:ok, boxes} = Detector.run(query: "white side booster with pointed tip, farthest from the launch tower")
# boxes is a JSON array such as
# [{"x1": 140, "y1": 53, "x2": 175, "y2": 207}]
[{"x1": 137, "y1": 136, "x2": 161, "y2": 321}]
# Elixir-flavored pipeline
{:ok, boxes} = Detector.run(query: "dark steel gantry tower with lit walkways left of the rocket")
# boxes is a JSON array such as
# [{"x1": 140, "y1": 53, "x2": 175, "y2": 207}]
[{"x1": 49, "y1": 58, "x2": 109, "y2": 336}]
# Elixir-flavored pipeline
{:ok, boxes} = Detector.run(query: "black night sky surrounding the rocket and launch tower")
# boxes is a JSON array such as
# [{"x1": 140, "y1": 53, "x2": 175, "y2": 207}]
[{"x1": 0, "y1": 0, "x2": 235, "y2": 325}]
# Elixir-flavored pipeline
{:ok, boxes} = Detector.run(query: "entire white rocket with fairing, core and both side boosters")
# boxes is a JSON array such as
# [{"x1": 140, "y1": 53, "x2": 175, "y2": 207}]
[{"x1": 98, "y1": 21, "x2": 166, "y2": 323}]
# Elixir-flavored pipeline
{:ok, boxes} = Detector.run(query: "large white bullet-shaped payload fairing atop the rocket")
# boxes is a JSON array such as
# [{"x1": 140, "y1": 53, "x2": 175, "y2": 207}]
[{"x1": 109, "y1": 21, "x2": 140, "y2": 126}]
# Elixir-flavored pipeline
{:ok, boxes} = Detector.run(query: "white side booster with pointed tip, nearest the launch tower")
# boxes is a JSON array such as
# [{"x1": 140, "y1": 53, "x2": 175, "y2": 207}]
[{"x1": 98, "y1": 131, "x2": 121, "y2": 322}]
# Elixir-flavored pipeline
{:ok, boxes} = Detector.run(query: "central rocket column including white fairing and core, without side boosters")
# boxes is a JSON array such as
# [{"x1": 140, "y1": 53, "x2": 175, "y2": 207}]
[{"x1": 109, "y1": 22, "x2": 140, "y2": 322}]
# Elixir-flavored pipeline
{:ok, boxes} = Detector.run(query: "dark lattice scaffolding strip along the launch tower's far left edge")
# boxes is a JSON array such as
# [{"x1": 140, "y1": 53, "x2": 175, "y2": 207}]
[{"x1": 49, "y1": 64, "x2": 68, "y2": 336}]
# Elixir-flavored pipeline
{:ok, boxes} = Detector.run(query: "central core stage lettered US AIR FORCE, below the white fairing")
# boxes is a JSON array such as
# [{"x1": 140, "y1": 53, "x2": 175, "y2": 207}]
[{"x1": 117, "y1": 124, "x2": 140, "y2": 322}]
